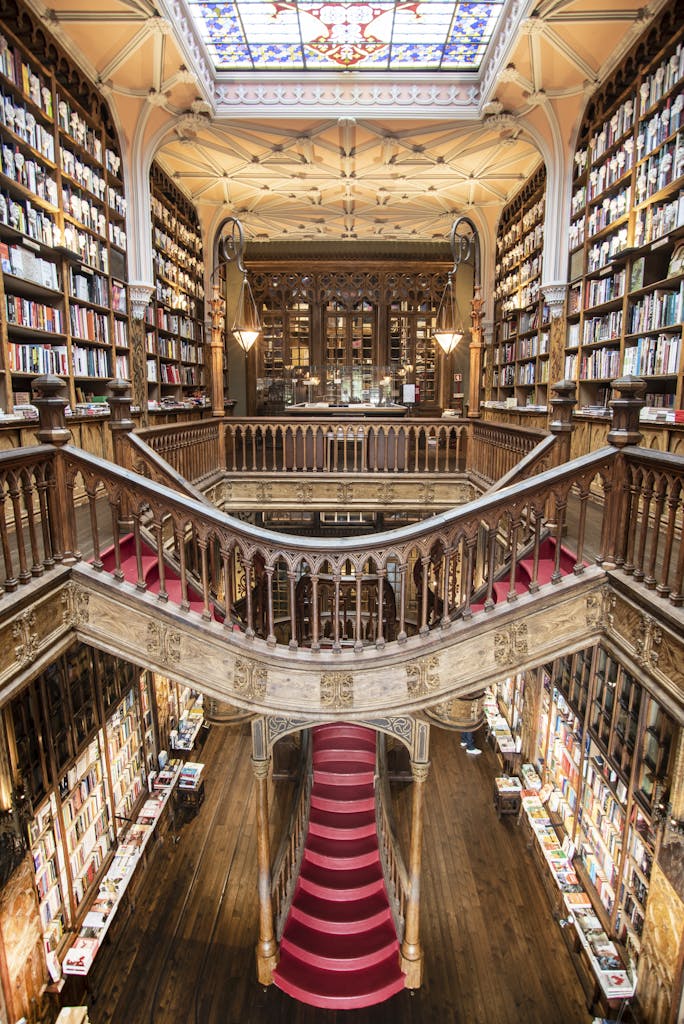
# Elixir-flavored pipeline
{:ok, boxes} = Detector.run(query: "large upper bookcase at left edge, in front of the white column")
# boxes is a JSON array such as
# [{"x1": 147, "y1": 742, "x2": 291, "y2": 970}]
[{"x1": 0, "y1": 8, "x2": 129, "y2": 413}]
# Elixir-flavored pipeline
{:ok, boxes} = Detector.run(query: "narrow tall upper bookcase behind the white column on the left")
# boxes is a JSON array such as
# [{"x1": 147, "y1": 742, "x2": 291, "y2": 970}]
[{"x1": 145, "y1": 165, "x2": 205, "y2": 409}]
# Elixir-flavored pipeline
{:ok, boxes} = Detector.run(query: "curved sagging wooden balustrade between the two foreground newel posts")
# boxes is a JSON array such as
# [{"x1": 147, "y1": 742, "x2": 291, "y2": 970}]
[{"x1": 58, "y1": 447, "x2": 616, "y2": 651}]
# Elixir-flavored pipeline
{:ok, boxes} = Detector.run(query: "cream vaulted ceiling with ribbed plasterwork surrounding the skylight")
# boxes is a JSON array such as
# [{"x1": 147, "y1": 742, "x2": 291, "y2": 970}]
[{"x1": 32, "y1": 0, "x2": 661, "y2": 241}]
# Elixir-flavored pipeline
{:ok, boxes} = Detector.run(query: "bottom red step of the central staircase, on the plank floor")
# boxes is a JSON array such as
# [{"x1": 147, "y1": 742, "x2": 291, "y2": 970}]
[{"x1": 273, "y1": 952, "x2": 404, "y2": 1010}]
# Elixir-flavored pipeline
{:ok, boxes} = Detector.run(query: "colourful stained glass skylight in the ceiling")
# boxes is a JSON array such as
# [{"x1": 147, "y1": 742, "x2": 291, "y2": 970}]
[{"x1": 186, "y1": 0, "x2": 506, "y2": 72}]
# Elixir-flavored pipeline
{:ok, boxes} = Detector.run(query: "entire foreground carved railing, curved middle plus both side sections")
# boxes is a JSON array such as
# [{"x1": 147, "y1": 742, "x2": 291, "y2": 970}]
[{"x1": 0, "y1": 382, "x2": 684, "y2": 622}]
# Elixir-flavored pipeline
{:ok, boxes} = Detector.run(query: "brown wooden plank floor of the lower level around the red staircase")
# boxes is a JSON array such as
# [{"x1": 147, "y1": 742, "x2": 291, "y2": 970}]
[{"x1": 77, "y1": 726, "x2": 592, "y2": 1024}]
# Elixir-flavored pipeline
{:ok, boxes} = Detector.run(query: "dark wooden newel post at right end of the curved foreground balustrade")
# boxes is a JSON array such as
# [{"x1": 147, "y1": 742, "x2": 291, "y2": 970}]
[{"x1": 597, "y1": 375, "x2": 647, "y2": 569}]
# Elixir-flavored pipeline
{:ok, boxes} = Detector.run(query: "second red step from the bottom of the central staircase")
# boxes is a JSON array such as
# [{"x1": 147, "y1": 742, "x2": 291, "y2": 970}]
[{"x1": 281, "y1": 920, "x2": 399, "y2": 971}]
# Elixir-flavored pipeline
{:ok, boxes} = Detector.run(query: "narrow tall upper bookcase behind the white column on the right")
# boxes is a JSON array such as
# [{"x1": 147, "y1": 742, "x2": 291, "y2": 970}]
[{"x1": 487, "y1": 166, "x2": 550, "y2": 412}]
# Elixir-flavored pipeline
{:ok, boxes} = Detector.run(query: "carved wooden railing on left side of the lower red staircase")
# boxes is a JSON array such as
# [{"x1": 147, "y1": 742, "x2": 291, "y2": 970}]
[{"x1": 271, "y1": 729, "x2": 313, "y2": 942}]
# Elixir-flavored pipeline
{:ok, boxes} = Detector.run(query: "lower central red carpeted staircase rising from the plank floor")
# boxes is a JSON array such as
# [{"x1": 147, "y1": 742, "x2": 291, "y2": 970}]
[{"x1": 273, "y1": 724, "x2": 404, "y2": 1010}]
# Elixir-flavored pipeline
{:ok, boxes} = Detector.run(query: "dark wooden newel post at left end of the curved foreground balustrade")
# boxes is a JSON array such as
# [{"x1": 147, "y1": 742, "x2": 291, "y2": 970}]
[{"x1": 33, "y1": 374, "x2": 80, "y2": 564}]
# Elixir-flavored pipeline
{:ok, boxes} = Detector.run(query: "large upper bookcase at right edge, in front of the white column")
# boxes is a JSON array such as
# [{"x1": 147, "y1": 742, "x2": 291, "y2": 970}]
[{"x1": 564, "y1": 22, "x2": 684, "y2": 420}]
